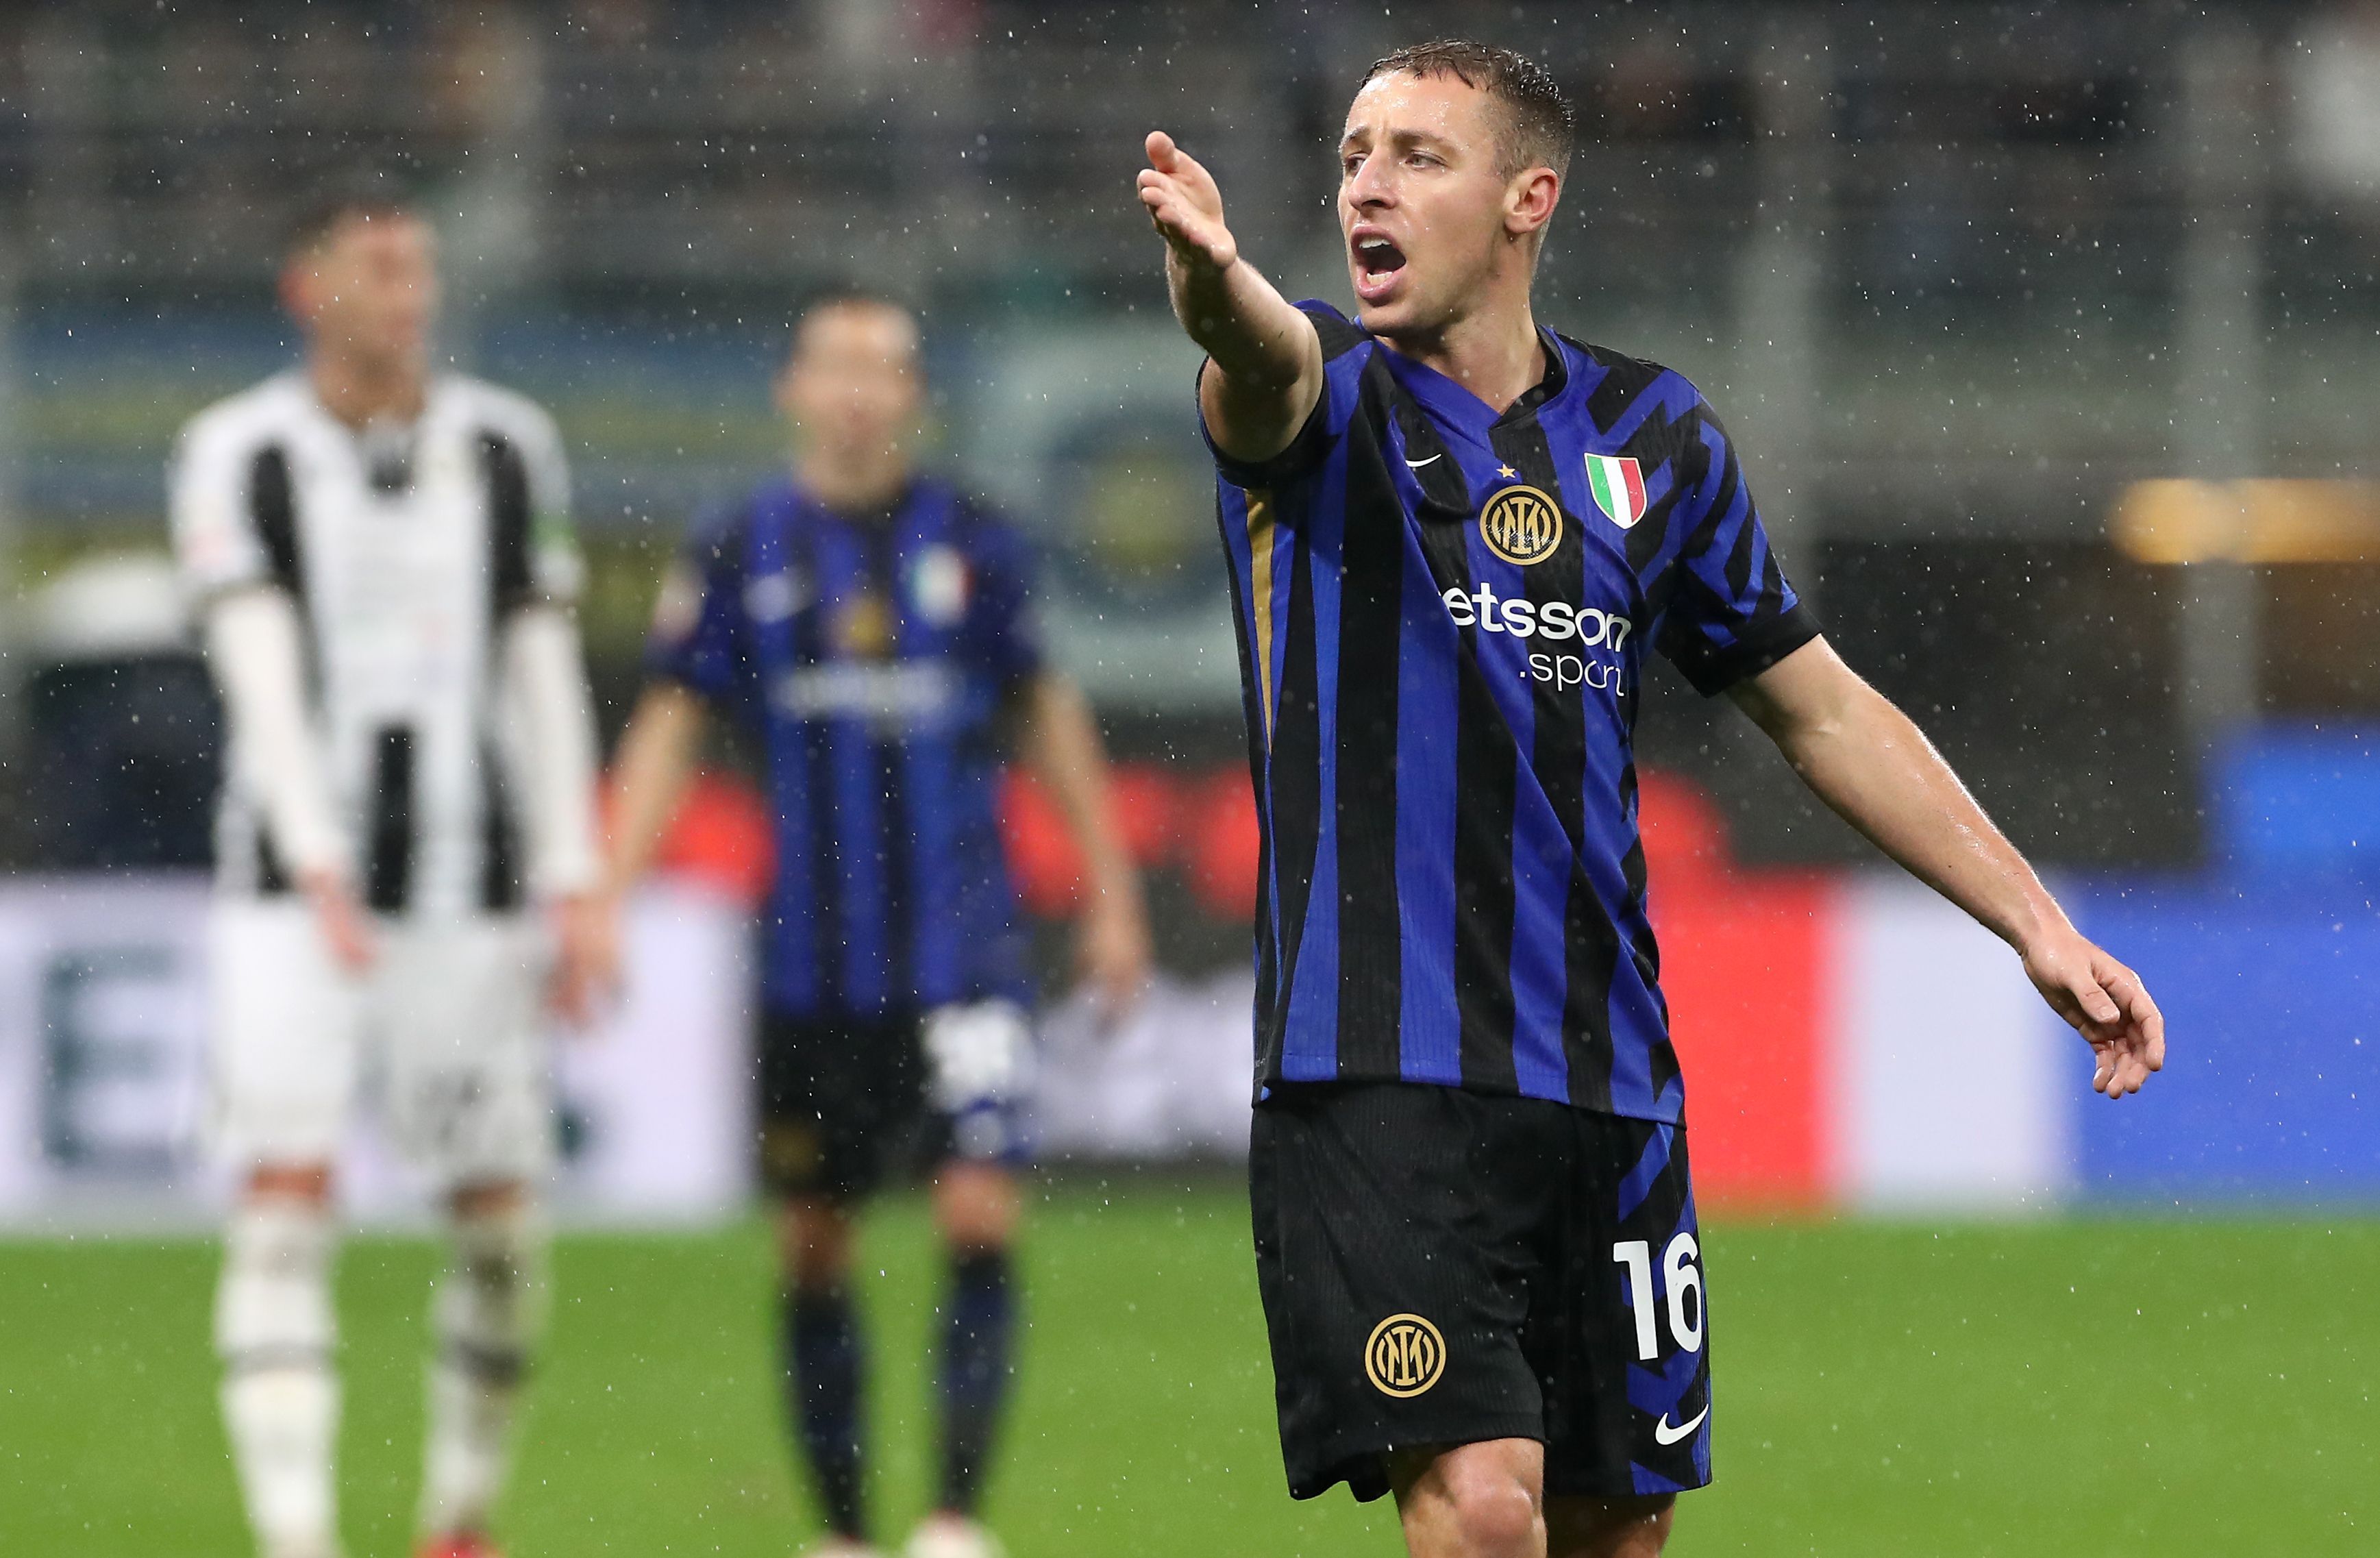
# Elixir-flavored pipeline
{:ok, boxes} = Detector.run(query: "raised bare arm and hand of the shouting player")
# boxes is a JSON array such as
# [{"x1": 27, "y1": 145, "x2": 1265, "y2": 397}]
[{"x1": 1140, "y1": 131, "x2": 1324, "y2": 464}]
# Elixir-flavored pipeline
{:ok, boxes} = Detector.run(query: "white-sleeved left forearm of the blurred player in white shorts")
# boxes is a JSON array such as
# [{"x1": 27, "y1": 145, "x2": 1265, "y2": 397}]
[{"x1": 205, "y1": 588, "x2": 347, "y2": 878}]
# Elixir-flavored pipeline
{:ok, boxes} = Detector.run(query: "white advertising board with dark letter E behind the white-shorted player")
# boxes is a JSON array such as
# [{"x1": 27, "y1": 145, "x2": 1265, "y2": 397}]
[{"x1": 0, "y1": 876, "x2": 752, "y2": 1227}]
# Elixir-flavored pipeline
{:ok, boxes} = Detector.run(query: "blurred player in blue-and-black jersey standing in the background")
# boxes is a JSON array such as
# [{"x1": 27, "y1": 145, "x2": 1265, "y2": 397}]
[{"x1": 595, "y1": 295, "x2": 1150, "y2": 1558}]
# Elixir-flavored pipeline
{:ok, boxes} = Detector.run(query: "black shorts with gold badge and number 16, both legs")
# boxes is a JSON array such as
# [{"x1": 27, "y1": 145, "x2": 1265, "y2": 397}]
[{"x1": 1250, "y1": 1083, "x2": 1711, "y2": 1498}]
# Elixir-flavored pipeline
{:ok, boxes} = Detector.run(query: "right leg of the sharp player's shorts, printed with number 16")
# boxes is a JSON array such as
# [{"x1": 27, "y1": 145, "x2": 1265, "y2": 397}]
[{"x1": 1528, "y1": 1113, "x2": 1711, "y2": 1498}]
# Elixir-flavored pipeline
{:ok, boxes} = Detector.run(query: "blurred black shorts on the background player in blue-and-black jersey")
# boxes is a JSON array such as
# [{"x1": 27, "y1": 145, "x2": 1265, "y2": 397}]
[{"x1": 759, "y1": 1011, "x2": 1024, "y2": 1201}]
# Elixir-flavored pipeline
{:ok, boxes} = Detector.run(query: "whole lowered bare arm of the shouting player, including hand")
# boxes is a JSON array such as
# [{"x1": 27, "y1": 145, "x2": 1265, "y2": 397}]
[{"x1": 1733, "y1": 637, "x2": 2166, "y2": 1099}]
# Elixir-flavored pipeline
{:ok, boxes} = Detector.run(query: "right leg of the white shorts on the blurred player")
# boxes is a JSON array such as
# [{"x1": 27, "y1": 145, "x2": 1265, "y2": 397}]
[{"x1": 373, "y1": 916, "x2": 554, "y2": 1189}]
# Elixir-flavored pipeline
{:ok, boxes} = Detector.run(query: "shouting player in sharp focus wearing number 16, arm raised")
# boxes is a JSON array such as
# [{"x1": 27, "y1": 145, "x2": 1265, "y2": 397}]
[{"x1": 1140, "y1": 42, "x2": 2164, "y2": 1558}]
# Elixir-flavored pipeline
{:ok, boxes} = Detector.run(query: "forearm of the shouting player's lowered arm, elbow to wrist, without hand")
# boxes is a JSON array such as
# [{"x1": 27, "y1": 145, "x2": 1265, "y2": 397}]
[{"x1": 1776, "y1": 682, "x2": 2066, "y2": 952}]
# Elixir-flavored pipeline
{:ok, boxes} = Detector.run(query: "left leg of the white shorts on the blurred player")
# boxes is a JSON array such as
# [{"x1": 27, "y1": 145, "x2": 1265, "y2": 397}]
[{"x1": 207, "y1": 897, "x2": 362, "y2": 1168}]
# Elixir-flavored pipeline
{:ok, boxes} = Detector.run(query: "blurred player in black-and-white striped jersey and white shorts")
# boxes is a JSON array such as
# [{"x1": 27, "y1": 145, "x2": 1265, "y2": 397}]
[{"x1": 171, "y1": 193, "x2": 599, "y2": 1558}]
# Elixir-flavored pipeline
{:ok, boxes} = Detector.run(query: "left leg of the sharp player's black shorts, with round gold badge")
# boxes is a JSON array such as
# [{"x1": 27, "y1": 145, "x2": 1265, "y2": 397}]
[{"x1": 1250, "y1": 1083, "x2": 1566, "y2": 1498}]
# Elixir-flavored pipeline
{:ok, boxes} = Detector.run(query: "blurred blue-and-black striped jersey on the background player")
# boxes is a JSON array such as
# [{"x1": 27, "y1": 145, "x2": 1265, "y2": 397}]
[{"x1": 645, "y1": 478, "x2": 1043, "y2": 1018}]
